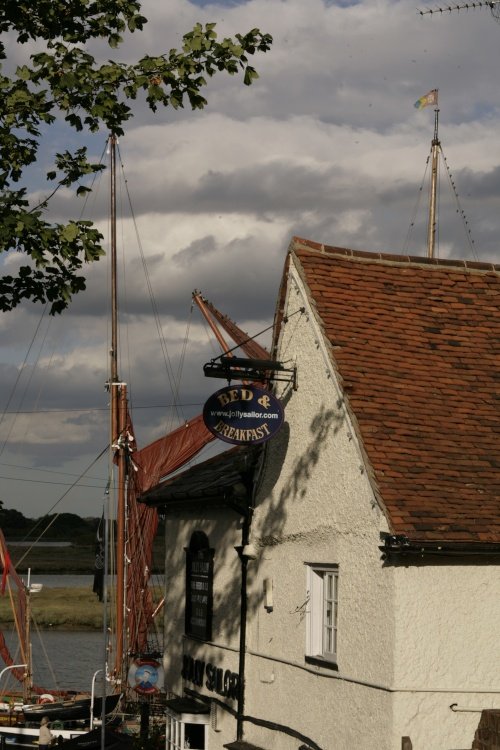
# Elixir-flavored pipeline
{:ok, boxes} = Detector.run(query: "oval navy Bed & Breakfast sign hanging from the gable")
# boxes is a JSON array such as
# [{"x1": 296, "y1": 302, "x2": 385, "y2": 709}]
[{"x1": 203, "y1": 385, "x2": 284, "y2": 445}]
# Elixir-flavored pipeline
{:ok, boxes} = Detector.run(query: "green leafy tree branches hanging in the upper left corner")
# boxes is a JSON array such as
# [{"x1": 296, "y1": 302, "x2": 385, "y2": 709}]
[{"x1": 0, "y1": 0, "x2": 272, "y2": 314}]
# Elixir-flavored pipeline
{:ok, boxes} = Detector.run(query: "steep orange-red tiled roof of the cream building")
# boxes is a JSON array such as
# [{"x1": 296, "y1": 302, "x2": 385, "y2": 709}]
[{"x1": 290, "y1": 237, "x2": 500, "y2": 543}]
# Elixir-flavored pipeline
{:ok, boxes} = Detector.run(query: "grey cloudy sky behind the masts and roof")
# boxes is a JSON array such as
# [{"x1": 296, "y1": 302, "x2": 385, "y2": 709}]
[{"x1": 0, "y1": 0, "x2": 500, "y2": 517}]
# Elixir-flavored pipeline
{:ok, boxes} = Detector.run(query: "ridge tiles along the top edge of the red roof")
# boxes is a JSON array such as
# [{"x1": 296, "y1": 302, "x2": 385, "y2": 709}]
[{"x1": 290, "y1": 236, "x2": 500, "y2": 273}]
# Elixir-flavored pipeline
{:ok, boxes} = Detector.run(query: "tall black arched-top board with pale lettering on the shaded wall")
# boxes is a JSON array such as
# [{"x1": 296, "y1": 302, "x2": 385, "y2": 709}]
[{"x1": 185, "y1": 531, "x2": 214, "y2": 641}]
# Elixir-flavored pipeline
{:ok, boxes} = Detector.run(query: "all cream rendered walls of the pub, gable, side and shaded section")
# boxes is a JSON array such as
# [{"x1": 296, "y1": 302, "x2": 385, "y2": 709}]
[{"x1": 161, "y1": 258, "x2": 500, "y2": 750}]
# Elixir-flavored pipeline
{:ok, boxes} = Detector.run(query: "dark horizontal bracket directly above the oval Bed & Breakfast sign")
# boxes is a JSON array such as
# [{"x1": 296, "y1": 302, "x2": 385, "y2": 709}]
[{"x1": 203, "y1": 356, "x2": 298, "y2": 391}]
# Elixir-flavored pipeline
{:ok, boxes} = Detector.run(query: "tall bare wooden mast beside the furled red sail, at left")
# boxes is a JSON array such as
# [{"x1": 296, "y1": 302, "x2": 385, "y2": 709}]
[{"x1": 109, "y1": 133, "x2": 127, "y2": 682}]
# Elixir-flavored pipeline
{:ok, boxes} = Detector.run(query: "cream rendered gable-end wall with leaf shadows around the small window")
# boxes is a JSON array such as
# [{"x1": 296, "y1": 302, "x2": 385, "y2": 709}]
[{"x1": 246, "y1": 270, "x2": 400, "y2": 750}]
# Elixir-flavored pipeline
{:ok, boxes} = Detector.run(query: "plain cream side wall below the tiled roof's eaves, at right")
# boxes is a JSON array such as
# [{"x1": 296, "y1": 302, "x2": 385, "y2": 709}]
[{"x1": 394, "y1": 561, "x2": 500, "y2": 750}]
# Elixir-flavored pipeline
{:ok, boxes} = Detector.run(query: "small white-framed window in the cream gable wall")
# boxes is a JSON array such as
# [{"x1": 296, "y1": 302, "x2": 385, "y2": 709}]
[{"x1": 306, "y1": 563, "x2": 339, "y2": 664}]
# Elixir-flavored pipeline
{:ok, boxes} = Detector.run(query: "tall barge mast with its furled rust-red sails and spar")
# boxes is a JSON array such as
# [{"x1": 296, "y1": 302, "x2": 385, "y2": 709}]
[{"x1": 105, "y1": 136, "x2": 269, "y2": 697}]
